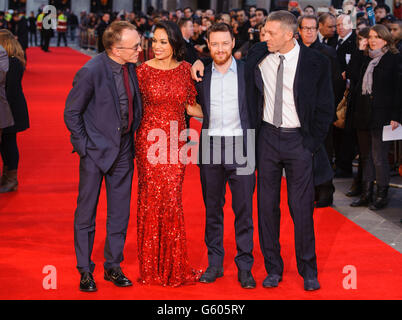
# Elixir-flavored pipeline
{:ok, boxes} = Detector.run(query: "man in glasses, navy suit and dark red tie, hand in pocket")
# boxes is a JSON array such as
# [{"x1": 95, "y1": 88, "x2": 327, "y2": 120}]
[{"x1": 64, "y1": 21, "x2": 142, "y2": 292}]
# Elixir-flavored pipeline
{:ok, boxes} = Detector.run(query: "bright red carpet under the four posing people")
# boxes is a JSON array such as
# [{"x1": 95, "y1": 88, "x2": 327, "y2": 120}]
[{"x1": 0, "y1": 48, "x2": 402, "y2": 300}]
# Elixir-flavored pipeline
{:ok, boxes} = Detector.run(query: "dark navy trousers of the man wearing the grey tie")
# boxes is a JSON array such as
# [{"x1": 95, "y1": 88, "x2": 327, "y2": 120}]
[{"x1": 257, "y1": 123, "x2": 317, "y2": 279}]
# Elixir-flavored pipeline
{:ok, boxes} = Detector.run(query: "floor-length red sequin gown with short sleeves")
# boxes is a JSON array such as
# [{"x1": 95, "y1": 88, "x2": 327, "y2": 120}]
[{"x1": 135, "y1": 62, "x2": 199, "y2": 286}]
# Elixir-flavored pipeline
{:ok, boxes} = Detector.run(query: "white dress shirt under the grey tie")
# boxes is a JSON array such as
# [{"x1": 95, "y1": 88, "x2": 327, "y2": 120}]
[{"x1": 259, "y1": 40, "x2": 301, "y2": 128}]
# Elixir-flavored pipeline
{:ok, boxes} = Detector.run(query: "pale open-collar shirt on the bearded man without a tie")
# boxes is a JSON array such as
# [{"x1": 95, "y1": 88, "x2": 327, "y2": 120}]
[{"x1": 208, "y1": 57, "x2": 243, "y2": 137}]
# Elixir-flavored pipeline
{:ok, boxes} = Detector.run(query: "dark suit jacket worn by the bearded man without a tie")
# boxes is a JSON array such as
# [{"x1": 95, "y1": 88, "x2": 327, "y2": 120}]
[{"x1": 196, "y1": 60, "x2": 255, "y2": 168}]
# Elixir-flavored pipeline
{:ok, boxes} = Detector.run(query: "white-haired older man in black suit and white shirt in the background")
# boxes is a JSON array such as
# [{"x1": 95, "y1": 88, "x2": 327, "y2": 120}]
[{"x1": 334, "y1": 14, "x2": 357, "y2": 178}]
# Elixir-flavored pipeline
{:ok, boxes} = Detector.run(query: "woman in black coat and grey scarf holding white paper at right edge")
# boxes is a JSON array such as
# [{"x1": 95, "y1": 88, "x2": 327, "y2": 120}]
[{"x1": 350, "y1": 25, "x2": 402, "y2": 210}]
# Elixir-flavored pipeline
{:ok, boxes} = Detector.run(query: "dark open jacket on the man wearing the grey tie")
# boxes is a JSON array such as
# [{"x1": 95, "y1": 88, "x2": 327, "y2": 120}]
[{"x1": 246, "y1": 42, "x2": 335, "y2": 185}]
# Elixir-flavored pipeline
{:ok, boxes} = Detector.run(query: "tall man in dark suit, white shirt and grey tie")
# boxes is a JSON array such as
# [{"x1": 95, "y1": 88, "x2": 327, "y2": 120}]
[{"x1": 246, "y1": 11, "x2": 334, "y2": 291}]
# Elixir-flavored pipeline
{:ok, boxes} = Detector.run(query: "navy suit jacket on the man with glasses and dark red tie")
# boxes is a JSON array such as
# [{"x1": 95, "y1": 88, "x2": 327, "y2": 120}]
[{"x1": 64, "y1": 52, "x2": 142, "y2": 173}]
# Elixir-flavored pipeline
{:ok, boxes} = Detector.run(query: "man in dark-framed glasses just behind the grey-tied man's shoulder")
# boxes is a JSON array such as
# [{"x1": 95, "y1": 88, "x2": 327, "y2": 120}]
[{"x1": 298, "y1": 16, "x2": 344, "y2": 208}]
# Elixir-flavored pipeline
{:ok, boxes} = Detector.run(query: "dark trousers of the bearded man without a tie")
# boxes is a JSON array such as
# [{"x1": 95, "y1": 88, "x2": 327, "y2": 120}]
[{"x1": 200, "y1": 139, "x2": 255, "y2": 271}]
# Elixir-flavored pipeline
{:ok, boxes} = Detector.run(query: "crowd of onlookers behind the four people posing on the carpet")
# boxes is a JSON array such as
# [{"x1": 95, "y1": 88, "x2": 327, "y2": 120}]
[{"x1": 0, "y1": 0, "x2": 402, "y2": 208}]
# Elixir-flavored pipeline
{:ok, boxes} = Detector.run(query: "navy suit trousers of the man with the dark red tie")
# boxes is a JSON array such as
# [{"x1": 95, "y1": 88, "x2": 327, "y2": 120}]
[{"x1": 74, "y1": 134, "x2": 134, "y2": 273}]
